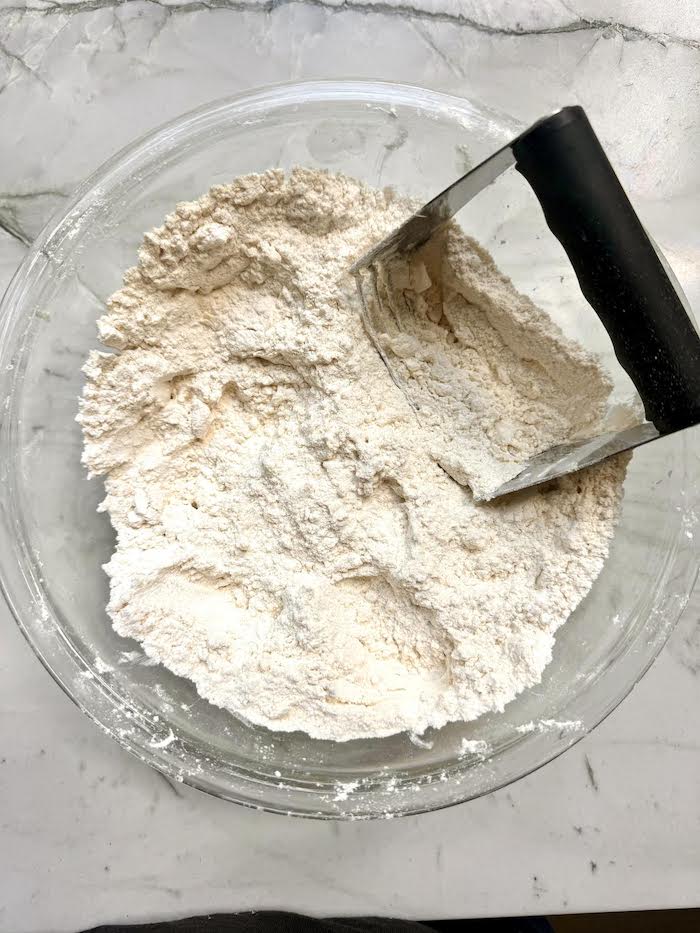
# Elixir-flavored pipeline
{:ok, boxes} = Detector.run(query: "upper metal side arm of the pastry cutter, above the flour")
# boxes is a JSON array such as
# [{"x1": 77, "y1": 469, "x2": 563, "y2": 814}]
[{"x1": 350, "y1": 140, "x2": 516, "y2": 275}]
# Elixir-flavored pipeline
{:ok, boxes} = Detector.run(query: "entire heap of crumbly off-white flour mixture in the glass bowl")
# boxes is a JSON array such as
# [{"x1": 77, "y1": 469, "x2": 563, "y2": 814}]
[{"x1": 79, "y1": 169, "x2": 624, "y2": 740}]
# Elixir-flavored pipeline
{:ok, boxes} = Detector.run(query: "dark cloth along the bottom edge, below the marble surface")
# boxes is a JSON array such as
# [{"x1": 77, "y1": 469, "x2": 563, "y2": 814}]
[{"x1": 85, "y1": 910, "x2": 552, "y2": 933}]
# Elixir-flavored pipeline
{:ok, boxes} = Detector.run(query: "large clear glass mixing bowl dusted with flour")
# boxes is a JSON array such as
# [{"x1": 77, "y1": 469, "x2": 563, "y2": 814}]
[{"x1": 0, "y1": 82, "x2": 698, "y2": 818}]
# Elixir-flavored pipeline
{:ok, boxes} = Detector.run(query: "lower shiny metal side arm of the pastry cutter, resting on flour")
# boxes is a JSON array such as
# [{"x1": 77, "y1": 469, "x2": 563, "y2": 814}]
[{"x1": 475, "y1": 421, "x2": 661, "y2": 502}]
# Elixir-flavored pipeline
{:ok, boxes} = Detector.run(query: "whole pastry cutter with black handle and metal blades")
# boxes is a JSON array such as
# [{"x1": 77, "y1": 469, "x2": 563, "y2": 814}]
[{"x1": 351, "y1": 106, "x2": 700, "y2": 499}]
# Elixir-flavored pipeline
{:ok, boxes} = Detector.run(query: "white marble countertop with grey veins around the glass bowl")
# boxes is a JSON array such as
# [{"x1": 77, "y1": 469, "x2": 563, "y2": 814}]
[{"x1": 0, "y1": 0, "x2": 700, "y2": 933}]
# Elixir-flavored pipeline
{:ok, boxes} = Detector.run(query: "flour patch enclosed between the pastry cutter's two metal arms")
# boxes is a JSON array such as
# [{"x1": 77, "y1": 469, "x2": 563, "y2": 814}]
[{"x1": 365, "y1": 230, "x2": 612, "y2": 498}]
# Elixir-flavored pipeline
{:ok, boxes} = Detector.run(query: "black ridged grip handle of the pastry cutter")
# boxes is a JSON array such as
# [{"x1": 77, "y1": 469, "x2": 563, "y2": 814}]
[{"x1": 513, "y1": 107, "x2": 700, "y2": 434}]
